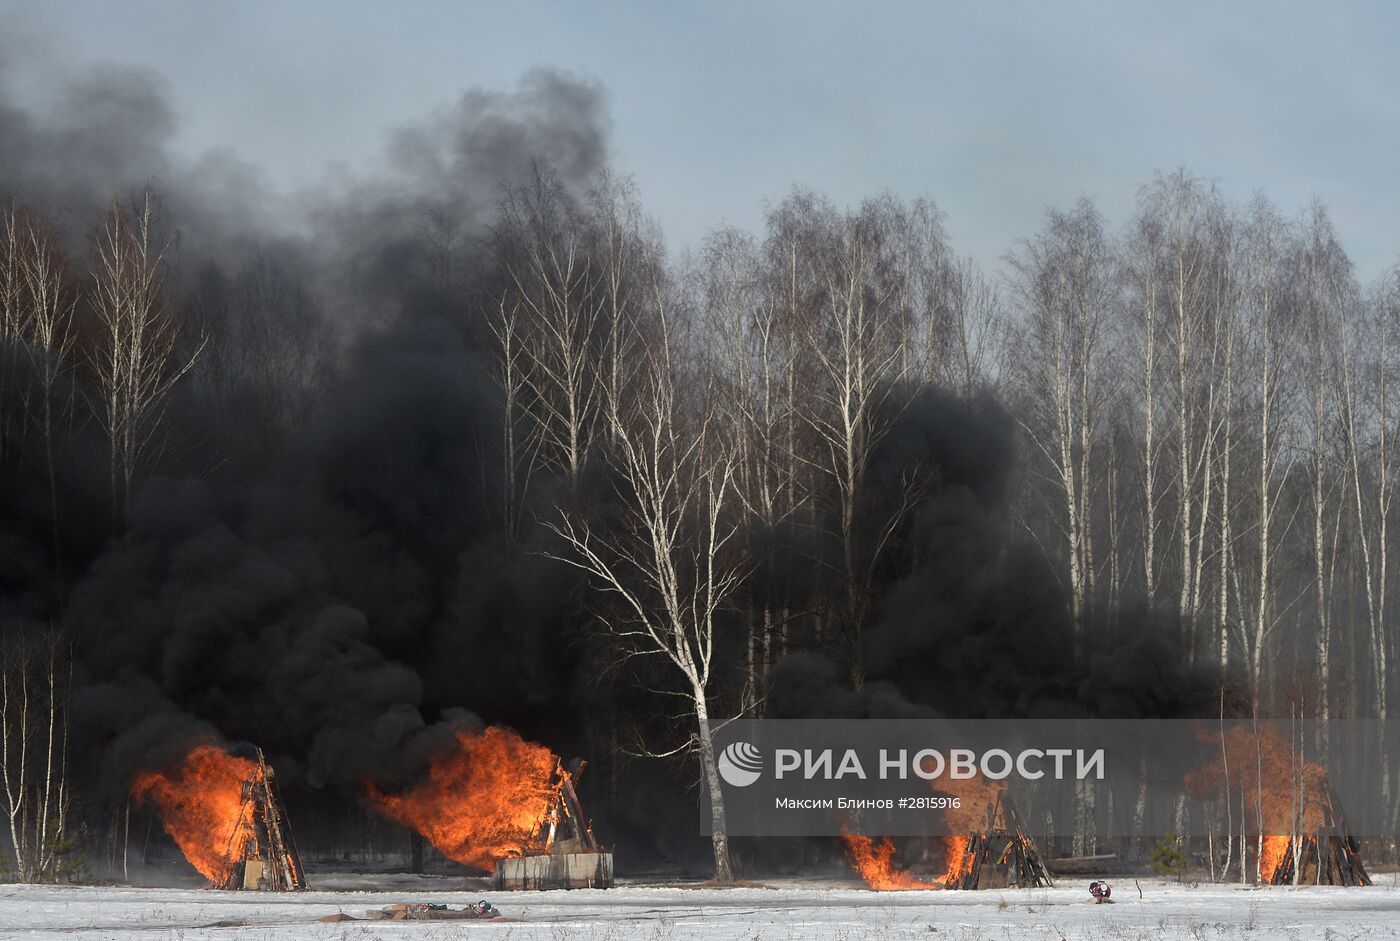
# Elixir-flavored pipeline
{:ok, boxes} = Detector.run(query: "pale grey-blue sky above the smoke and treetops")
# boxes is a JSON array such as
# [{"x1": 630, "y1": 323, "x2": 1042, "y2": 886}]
[{"x1": 0, "y1": 0, "x2": 1400, "y2": 280}]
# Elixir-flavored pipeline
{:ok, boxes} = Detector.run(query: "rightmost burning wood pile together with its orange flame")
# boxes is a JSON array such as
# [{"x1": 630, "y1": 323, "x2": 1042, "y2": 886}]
[{"x1": 1186, "y1": 725, "x2": 1371, "y2": 886}]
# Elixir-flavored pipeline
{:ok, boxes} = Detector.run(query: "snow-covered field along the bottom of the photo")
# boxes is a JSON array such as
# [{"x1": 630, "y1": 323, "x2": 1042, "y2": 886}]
[{"x1": 0, "y1": 874, "x2": 1400, "y2": 941}]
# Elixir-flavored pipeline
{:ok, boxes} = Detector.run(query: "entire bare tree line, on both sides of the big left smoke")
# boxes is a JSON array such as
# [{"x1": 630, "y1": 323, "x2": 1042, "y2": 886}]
[{"x1": 0, "y1": 168, "x2": 1400, "y2": 878}]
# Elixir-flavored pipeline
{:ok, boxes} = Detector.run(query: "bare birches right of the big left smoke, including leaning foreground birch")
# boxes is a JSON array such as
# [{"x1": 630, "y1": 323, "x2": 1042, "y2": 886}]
[{"x1": 478, "y1": 171, "x2": 1400, "y2": 872}]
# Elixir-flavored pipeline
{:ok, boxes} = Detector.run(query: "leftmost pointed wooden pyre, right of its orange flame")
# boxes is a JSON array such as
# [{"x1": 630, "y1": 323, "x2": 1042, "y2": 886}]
[{"x1": 214, "y1": 748, "x2": 307, "y2": 892}]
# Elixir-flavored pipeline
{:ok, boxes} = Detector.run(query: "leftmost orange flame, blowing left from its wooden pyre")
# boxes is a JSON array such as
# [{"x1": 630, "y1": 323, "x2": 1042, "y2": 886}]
[{"x1": 132, "y1": 745, "x2": 262, "y2": 885}]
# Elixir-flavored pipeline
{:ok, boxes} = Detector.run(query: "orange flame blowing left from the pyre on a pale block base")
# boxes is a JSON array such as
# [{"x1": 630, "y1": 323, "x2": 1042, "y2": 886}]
[{"x1": 365, "y1": 727, "x2": 557, "y2": 871}]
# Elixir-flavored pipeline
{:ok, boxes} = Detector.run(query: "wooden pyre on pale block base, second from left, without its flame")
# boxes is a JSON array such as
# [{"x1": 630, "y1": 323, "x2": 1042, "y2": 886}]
[{"x1": 496, "y1": 762, "x2": 613, "y2": 891}]
